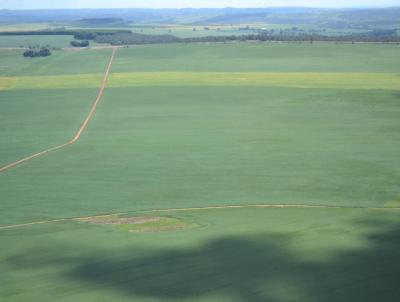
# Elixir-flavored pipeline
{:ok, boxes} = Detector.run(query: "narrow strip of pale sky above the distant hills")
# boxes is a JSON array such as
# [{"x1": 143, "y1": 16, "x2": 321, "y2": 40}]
[{"x1": 0, "y1": 0, "x2": 400, "y2": 9}]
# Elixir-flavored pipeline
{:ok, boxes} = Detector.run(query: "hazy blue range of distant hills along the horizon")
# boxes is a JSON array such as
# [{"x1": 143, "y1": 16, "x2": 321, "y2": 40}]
[{"x1": 0, "y1": 7, "x2": 400, "y2": 29}]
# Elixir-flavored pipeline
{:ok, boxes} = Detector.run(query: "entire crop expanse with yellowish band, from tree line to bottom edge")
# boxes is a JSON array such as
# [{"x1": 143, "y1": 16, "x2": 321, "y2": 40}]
[{"x1": 0, "y1": 43, "x2": 400, "y2": 302}]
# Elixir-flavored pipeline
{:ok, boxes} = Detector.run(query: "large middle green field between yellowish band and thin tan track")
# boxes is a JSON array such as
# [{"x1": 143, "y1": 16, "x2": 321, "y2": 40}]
[{"x1": 0, "y1": 86, "x2": 400, "y2": 224}]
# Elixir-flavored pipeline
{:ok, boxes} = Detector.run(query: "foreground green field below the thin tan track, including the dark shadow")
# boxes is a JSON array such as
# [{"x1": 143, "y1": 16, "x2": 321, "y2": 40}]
[{"x1": 0, "y1": 209, "x2": 400, "y2": 302}]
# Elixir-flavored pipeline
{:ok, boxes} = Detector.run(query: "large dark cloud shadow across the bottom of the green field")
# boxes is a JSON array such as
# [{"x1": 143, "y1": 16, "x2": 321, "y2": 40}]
[{"x1": 5, "y1": 220, "x2": 400, "y2": 302}]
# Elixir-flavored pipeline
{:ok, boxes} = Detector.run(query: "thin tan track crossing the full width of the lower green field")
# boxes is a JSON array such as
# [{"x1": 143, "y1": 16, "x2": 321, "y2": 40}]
[{"x1": 0, "y1": 204, "x2": 400, "y2": 230}]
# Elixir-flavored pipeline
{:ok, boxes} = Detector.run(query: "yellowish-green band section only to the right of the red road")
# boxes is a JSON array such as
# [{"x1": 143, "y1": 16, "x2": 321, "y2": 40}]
[{"x1": 109, "y1": 72, "x2": 400, "y2": 90}]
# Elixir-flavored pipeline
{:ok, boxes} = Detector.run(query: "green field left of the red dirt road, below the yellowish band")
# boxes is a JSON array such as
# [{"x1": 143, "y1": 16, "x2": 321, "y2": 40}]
[{"x1": 0, "y1": 89, "x2": 97, "y2": 166}]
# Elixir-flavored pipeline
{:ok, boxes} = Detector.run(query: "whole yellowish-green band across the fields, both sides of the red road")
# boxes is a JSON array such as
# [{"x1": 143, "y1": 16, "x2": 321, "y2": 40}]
[{"x1": 0, "y1": 72, "x2": 400, "y2": 90}]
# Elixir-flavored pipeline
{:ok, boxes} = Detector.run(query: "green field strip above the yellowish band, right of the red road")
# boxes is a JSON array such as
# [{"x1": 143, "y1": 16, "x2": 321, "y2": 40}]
[{"x1": 113, "y1": 43, "x2": 400, "y2": 73}]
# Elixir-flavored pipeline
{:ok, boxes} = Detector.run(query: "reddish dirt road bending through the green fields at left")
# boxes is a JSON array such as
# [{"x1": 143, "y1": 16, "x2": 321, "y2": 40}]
[{"x1": 0, "y1": 47, "x2": 117, "y2": 173}]
